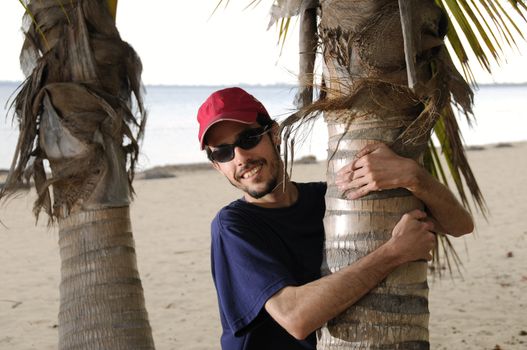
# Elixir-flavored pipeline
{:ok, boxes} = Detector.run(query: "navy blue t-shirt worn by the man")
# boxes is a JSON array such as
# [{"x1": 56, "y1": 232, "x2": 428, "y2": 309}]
[{"x1": 211, "y1": 182, "x2": 326, "y2": 350}]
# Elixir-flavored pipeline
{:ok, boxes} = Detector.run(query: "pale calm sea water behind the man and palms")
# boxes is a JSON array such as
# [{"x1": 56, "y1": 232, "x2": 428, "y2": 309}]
[{"x1": 0, "y1": 82, "x2": 527, "y2": 169}]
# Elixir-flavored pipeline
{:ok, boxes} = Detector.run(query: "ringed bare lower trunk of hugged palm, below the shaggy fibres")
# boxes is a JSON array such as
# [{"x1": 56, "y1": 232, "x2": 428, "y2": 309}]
[{"x1": 318, "y1": 116, "x2": 429, "y2": 349}]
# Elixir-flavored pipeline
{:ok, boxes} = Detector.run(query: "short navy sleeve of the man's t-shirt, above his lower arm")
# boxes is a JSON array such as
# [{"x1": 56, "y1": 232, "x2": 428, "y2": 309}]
[{"x1": 211, "y1": 209, "x2": 295, "y2": 335}]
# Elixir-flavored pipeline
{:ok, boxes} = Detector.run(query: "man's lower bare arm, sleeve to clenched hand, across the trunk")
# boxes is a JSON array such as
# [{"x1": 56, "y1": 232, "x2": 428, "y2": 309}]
[{"x1": 265, "y1": 210, "x2": 435, "y2": 339}]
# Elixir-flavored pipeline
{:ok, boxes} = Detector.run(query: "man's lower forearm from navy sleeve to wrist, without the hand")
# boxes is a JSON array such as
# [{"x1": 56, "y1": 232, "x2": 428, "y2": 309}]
[{"x1": 265, "y1": 244, "x2": 401, "y2": 339}]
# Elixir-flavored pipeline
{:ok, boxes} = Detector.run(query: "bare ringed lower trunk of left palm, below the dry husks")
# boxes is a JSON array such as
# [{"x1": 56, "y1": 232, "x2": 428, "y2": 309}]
[{"x1": 59, "y1": 206, "x2": 154, "y2": 349}]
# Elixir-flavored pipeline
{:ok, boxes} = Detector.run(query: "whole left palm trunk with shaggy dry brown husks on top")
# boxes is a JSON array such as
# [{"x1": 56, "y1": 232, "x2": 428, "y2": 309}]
[{"x1": 0, "y1": 0, "x2": 154, "y2": 350}]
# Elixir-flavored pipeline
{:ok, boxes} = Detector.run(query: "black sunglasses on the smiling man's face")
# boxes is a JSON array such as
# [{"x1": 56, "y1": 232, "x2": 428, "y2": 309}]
[{"x1": 207, "y1": 125, "x2": 271, "y2": 163}]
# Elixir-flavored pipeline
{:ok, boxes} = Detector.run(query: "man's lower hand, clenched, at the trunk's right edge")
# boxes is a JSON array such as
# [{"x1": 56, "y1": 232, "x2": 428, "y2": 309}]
[{"x1": 386, "y1": 209, "x2": 435, "y2": 263}]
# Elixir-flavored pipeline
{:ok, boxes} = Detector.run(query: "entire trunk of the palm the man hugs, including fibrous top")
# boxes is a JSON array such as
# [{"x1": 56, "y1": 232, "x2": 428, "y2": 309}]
[{"x1": 314, "y1": 0, "x2": 471, "y2": 350}]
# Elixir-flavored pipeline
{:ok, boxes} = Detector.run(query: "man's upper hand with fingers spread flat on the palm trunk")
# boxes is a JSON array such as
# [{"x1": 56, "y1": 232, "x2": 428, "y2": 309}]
[{"x1": 335, "y1": 143, "x2": 423, "y2": 199}]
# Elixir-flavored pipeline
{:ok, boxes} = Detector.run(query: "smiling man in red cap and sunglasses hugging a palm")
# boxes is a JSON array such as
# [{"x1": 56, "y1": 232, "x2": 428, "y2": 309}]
[{"x1": 198, "y1": 88, "x2": 473, "y2": 350}]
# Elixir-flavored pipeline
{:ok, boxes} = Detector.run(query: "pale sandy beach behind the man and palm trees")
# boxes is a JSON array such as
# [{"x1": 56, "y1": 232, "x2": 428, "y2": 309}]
[{"x1": 0, "y1": 142, "x2": 527, "y2": 350}]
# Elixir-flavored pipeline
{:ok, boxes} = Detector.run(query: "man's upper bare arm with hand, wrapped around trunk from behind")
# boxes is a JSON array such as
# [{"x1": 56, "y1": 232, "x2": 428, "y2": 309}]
[{"x1": 335, "y1": 143, "x2": 474, "y2": 236}]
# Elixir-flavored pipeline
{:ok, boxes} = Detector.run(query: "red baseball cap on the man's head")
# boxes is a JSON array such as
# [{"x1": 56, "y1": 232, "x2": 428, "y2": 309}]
[{"x1": 198, "y1": 87, "x2": 271, "y2": 149}]
